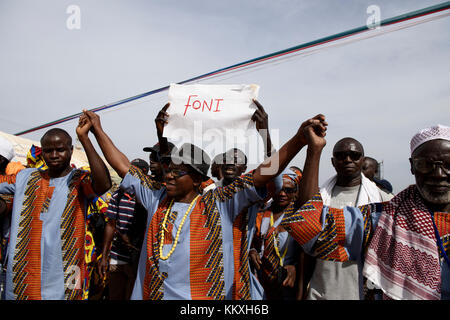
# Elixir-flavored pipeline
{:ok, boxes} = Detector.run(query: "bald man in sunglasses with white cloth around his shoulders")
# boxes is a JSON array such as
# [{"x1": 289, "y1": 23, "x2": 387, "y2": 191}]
[{"x1": 307, "y1": 137, "x2": 392, "y2": 300}]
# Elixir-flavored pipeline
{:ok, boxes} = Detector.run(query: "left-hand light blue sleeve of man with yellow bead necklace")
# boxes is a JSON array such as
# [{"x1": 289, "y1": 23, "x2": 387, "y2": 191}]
[{"x1": 120, "y1": 166, "x2": 163, "y2": 208}]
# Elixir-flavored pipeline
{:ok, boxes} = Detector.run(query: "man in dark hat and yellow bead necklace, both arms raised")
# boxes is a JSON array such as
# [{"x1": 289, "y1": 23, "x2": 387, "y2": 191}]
[{"x1": 81, "y1": 104, "x2": 327, "y2": 300}]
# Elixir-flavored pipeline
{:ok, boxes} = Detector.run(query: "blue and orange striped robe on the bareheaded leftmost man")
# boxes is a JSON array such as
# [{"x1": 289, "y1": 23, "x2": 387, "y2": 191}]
[{"x1": 0, "y1": 169, "x2": 95, "y2": 300}]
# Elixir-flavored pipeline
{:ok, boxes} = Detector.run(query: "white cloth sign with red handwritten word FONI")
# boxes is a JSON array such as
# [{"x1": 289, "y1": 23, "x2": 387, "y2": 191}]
[{"x1": 164, "y1": 84, "x2": 259, "y2": 157}]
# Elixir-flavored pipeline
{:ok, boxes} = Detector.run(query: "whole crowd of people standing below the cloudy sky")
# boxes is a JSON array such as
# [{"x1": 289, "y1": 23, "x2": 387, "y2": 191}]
[{"x1": 0, "y1": 100, "x2": 450, "y2": 300}]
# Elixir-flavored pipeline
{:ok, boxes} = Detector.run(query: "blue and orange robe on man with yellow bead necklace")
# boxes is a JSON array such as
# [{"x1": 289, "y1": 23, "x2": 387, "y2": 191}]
[{"x1": 121, "y1": 167, "x2": 265, "y2": 300}]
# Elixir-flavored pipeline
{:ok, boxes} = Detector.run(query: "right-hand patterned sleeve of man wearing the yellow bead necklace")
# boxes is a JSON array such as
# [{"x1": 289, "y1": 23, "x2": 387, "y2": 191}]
[{"x1": 211, "y1": 173, "x2": 267, "y2": 220}]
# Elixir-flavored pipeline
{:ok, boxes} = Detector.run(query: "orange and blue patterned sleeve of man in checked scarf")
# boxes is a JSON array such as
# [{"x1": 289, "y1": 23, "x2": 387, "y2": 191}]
[{"x1": 281, "y1": 193, "x2": 377, "y2": 261}]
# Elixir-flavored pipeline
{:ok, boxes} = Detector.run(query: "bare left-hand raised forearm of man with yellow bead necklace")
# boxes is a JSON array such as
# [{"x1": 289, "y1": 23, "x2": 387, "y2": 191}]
[{"x1": 83, "y1": 110, "x2": 131, "y2": 178}]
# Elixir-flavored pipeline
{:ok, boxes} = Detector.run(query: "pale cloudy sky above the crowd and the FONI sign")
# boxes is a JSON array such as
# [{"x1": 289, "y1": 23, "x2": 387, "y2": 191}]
[{"x1": 0, "y1": 0, "x2": 450, "y2": 192}]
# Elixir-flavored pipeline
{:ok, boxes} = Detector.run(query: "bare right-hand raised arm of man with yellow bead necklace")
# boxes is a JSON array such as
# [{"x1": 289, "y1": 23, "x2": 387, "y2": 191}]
[{"x1": 253, "y1": 114, "x2": 328, "y2": 187}]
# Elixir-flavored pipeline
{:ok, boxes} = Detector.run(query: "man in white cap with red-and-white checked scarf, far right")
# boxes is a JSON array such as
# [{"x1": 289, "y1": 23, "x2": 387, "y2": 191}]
[{"x1": 282, "y1": 125, "x2": 450, "y2": 300}]
